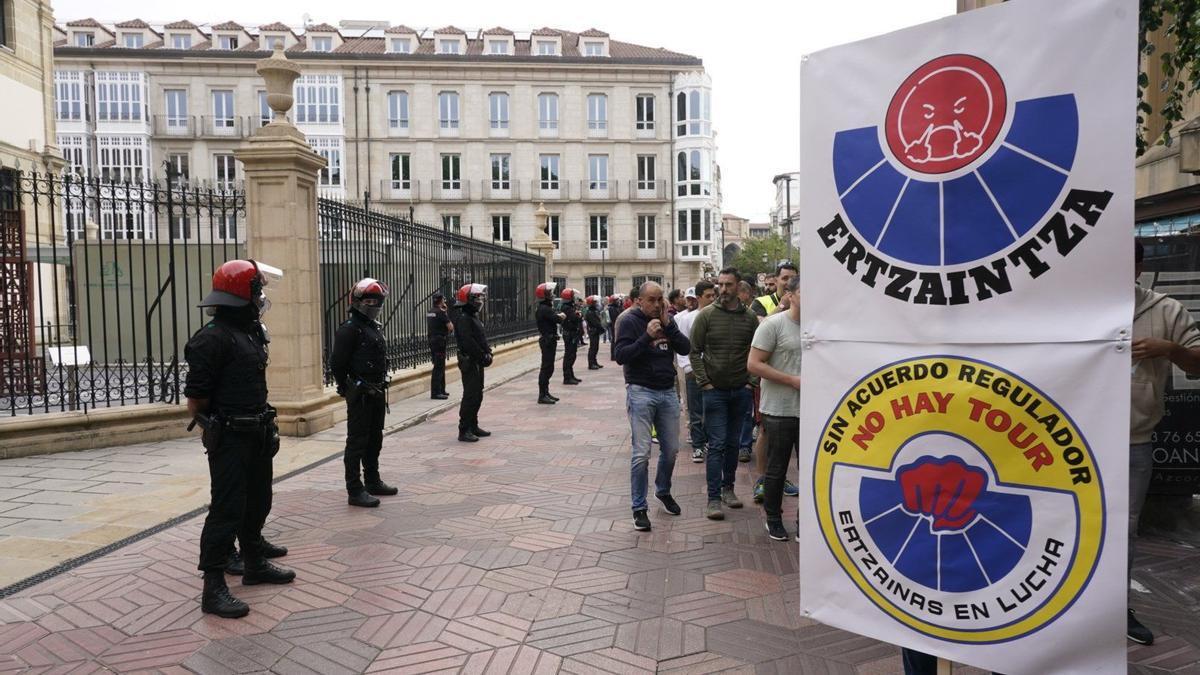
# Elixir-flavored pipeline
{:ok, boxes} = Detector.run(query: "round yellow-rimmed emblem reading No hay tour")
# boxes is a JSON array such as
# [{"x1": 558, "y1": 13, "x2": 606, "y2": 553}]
[{"x1": 812, "y1": 356, "x2": 1105, "y2": 644}]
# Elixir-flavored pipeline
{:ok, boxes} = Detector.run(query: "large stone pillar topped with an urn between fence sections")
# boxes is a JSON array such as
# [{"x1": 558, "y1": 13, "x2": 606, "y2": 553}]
[{"x1": 234, "y1": 50, "x2": 332, "y2": 436}]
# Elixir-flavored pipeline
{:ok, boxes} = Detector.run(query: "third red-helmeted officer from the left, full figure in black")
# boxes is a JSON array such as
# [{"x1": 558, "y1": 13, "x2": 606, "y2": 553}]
[{"x1": 454, "y1": 283, "x2": 492, "y2": 443}]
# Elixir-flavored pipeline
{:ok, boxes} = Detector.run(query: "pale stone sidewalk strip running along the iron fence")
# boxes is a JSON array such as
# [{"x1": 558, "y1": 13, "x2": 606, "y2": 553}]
[{"x1": 0, "y1": 343, "x2": 539, "y2": 589}]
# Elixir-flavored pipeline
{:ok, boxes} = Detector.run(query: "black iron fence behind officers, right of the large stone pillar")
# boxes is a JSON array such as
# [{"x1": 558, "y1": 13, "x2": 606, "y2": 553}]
[{"x1": 317, "y1": 198, "x2": 546, "y2": 383}]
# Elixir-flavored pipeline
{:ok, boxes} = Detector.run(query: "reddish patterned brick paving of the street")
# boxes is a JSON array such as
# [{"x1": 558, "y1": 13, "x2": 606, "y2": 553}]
[{"x1": 0, "y1": 348, "x2": 1200, "y2": 674}]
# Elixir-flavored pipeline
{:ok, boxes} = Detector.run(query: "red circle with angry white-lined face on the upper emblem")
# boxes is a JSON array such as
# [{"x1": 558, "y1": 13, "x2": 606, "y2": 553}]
[{"x1": 884, "y1": 54, "x2": 1008, "y2": 174}]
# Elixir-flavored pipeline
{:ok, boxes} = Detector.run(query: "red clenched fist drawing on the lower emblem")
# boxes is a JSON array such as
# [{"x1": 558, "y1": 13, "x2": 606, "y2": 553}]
[{"x1": 896, "y1": 456, "x2": 988, "y2": 532}]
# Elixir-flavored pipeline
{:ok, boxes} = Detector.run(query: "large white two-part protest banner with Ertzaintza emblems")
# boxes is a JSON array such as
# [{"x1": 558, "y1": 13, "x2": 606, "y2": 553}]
[{"x1": 800, "y1": 0, "x2": 1138, "y2": 675}]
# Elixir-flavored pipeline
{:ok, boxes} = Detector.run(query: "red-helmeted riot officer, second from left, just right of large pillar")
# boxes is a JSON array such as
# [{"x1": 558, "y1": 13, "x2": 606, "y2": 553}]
[{"x1": 329, "y1": 277, "x2": 400, "y2": 508}]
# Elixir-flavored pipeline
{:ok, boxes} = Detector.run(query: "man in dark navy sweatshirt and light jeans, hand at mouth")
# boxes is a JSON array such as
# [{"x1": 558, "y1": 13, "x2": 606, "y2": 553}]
[{"x1": 613, "y1": 281, "x2": 691, "y2": 532}]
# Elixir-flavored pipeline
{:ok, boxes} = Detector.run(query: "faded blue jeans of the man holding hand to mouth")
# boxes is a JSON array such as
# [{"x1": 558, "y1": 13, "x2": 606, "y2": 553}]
[{"x1": 625, "y1": 384, "x2": 679, "y2": 510}]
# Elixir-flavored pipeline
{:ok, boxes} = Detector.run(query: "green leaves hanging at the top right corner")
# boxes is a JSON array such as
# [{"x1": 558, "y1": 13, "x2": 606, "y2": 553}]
[{"x1": 1138, "y1": 0, "x2": 1200, "y2": 155}]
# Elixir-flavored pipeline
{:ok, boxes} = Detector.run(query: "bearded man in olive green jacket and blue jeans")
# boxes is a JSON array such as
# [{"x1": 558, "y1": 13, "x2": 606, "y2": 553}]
[{"x1": 689, "y1": 268, "x2": 758, "y2": 520}]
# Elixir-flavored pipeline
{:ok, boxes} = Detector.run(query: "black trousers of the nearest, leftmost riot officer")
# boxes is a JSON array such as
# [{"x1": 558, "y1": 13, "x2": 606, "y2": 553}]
[{"x1": 198, "y1": 430, "x2": 271, "y2": 572}]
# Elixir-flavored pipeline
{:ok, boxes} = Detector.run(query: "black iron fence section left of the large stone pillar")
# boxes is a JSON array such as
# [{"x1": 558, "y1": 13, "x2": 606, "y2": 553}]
[{"x1": 0, "y1": 169, "x2": 246, "y2": 416}]
